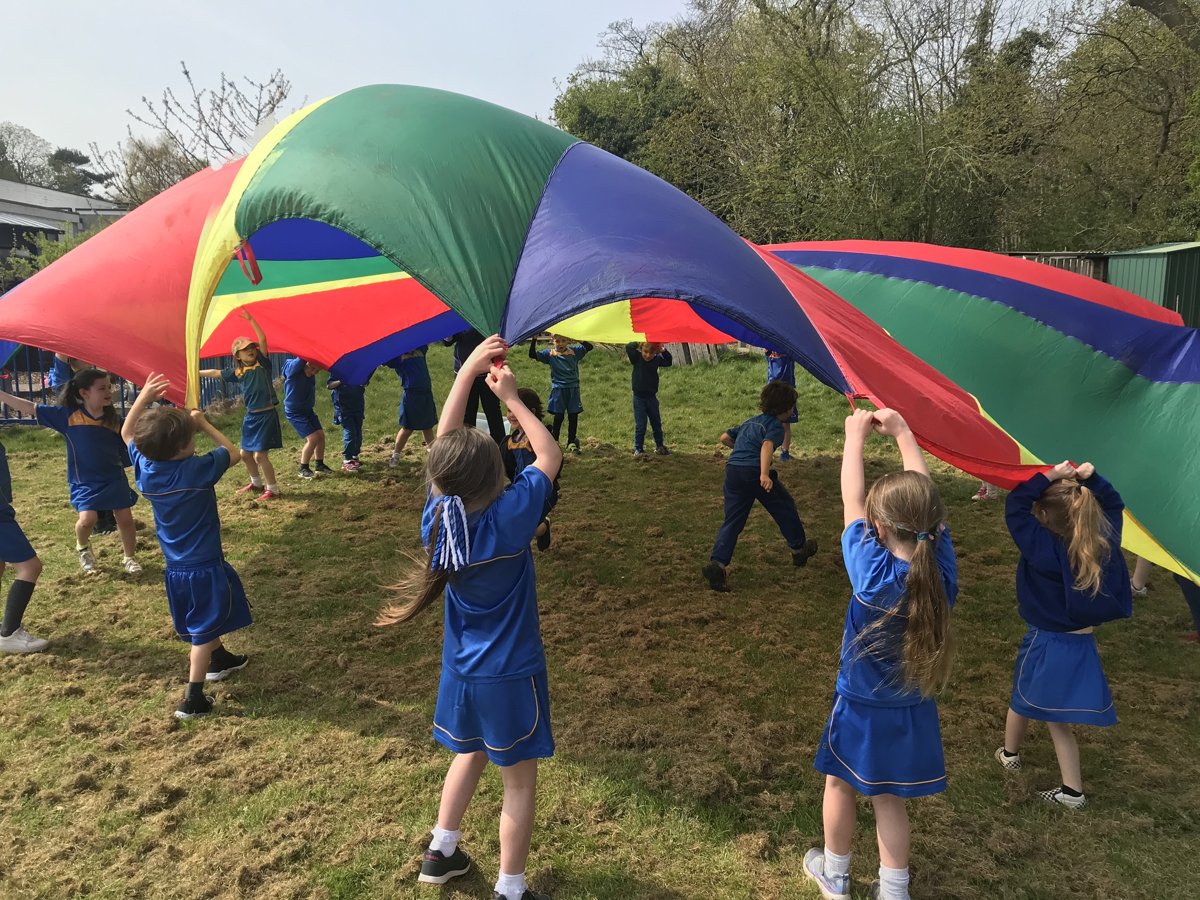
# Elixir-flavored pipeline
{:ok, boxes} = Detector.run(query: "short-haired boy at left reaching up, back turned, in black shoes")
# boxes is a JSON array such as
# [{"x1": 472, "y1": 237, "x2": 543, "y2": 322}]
[{"x1": 121, "y1": 373, "x2": 251, "y2": 719}]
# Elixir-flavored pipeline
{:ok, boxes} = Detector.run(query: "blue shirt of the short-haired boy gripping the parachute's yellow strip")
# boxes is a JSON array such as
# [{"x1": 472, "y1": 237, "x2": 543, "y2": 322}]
[{"x1": 128, "y1": 442, "x2": 229, "y2": 566}]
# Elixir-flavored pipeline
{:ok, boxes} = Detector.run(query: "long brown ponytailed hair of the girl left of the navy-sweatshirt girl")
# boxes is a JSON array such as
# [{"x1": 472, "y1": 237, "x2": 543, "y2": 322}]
[{"x1": 862, "y1": 472, "x2": 954, "y2": 697}]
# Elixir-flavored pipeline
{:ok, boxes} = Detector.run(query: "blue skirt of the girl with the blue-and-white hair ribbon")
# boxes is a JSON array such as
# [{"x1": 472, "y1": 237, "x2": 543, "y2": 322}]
[{"x1": 433, "y1": 667, "x2": 554, "y2": 766}]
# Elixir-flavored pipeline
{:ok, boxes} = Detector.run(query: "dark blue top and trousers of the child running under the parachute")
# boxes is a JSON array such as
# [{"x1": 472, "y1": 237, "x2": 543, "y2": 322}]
[{"x1": 709, "y1": 414, "x2": 808, "y2": 565}]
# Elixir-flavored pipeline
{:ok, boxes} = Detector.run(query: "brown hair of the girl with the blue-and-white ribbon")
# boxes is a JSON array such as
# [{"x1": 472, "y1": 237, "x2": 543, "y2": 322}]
[{"x1": 376, "y1": 428, "x2": 506, "y2": 625}]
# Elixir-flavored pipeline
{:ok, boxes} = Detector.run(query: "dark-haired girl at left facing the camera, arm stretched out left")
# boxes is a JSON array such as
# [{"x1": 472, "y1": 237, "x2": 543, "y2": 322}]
[{"x1": 0, "y1": 367, "x2": 142, "y2": 575}]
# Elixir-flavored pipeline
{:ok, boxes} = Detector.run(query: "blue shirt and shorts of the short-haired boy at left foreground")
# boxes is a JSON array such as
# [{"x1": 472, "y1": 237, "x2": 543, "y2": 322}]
[{"x1": 128, "y1": 442, "x2": 252, "y2": 644}]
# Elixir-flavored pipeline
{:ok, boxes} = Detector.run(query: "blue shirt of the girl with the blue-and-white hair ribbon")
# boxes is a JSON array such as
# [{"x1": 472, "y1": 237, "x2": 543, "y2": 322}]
[{"x1": 421, "y1": 467, "x2": 552, "y2": 682}]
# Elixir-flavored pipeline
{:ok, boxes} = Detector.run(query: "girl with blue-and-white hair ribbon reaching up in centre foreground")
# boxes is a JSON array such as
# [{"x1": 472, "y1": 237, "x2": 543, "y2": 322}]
[{"x1": 378, "y1": 335, "x2": 563, "y2": 900}]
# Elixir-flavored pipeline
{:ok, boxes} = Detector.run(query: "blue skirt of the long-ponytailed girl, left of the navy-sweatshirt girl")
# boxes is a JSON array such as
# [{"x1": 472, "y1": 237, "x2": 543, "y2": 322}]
[{"x1": 812, "y1": 695, "x2": 946, "y2": 797}]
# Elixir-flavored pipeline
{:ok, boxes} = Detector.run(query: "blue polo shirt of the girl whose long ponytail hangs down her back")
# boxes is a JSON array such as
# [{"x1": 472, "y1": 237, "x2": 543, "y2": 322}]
[{"x1": 838, "y1": 518, "x2": 959, "y2": 707}]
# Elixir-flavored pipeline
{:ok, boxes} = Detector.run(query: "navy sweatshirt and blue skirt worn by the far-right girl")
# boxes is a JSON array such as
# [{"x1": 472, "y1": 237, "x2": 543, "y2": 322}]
[{"x1": 1004, "y1": 474, "x2": 1133, "y2": 726}]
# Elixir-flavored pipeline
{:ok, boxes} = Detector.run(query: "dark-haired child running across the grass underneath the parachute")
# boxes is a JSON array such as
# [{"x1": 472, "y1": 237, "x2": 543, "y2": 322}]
[{"x1": 701, "y1": 382, "x2": 817, "y2": 590}]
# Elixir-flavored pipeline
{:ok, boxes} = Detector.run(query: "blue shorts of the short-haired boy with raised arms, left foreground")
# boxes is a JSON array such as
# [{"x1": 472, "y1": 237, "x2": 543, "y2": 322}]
[{"x1": 164, "y1": 559, "x2": 252, "y2": 644}]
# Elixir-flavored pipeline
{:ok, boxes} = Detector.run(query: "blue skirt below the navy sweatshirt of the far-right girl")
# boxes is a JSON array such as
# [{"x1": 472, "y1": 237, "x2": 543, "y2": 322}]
[{"x1": 1009, "y1": 628, "x2": 1117, "y2": 726}]
